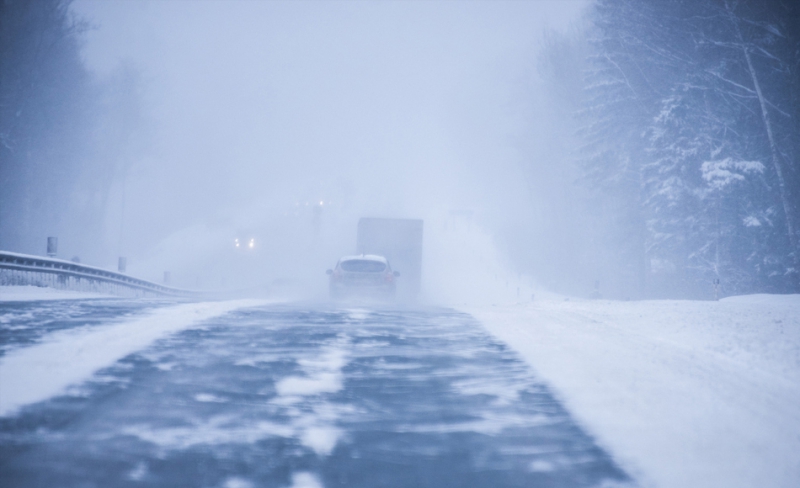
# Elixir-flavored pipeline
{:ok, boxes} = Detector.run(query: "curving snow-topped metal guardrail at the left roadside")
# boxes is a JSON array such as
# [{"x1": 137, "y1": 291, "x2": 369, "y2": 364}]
[{"x1": 0, "y1": 251, "x2": 200, "y2": 297}]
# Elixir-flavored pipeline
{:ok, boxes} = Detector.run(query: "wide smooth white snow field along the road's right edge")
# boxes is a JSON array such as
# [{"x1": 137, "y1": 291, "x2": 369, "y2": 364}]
[{"x1": 467, "y1": 295, "x2": 800, "y2": 488}]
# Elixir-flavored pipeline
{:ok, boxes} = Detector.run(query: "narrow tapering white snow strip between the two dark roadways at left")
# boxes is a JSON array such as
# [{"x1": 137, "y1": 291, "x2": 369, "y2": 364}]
[{"x1": 0, "y1": 300, "x2": 266, "y2": 417}]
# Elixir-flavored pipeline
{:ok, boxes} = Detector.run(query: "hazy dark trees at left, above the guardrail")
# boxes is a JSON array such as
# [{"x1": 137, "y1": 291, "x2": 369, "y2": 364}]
[{"x1": 0, "y1": 0, "x2": 143, "y2": 261}]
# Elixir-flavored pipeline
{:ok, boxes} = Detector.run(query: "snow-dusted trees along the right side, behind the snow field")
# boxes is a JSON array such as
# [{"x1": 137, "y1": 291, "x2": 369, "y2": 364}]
[{"x1": 579, "y1": 0, "x2": 800, "y2": 294}]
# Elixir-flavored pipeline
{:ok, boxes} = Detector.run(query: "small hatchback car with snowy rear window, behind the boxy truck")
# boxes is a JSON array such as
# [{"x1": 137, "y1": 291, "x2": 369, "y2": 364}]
[{"x1": 327, "y1": 254, "x2": 400, "y2": 300}]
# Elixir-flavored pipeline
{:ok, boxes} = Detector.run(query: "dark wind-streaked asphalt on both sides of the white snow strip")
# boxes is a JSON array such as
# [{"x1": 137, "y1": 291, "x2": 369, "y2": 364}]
[{"x1": 0, "y1": 300, "x2": 632, "y2": 488}]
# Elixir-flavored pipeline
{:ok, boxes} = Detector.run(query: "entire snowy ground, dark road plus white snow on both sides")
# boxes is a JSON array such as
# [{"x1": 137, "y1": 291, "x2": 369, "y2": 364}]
[{"x1": 0, "y1": 295, "x2": 800, "y2": 488}]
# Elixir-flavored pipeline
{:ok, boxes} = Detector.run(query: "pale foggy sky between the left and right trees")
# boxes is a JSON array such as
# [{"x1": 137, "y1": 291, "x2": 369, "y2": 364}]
[{"x1": 74, "y1": 0, "x2": 586, "y2": 284}]
